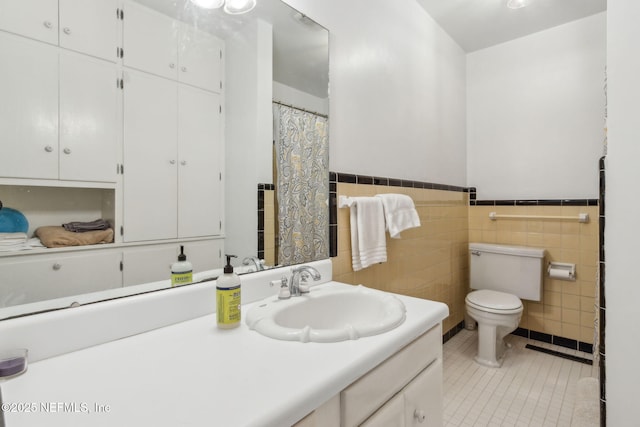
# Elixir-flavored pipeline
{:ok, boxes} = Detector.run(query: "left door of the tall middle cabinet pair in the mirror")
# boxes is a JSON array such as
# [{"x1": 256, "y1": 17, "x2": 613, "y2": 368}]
[{"x1": 123, "y1": 70, "x2": 178, "y2": 242}]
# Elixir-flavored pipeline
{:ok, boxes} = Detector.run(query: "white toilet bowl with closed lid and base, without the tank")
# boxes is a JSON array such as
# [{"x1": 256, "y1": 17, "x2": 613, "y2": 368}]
[{"x1": 465, "y1": 289, "x2": 523, "y2": 368}]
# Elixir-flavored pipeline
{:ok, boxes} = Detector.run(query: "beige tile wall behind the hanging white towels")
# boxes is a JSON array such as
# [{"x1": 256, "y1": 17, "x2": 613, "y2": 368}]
[{"x1": 332, "y1": 183, "x2": 469, "y2": 331}]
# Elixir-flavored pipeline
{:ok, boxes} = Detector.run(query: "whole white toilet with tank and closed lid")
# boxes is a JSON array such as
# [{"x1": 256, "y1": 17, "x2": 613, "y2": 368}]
[{"x1": 465, "y1": 243, "x2": 544, "y2": 368}]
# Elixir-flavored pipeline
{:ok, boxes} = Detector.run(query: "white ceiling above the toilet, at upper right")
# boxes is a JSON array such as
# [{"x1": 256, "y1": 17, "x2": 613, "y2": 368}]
[{"x1": 416, "y1": 0, "x2": 607, "y2": 52}]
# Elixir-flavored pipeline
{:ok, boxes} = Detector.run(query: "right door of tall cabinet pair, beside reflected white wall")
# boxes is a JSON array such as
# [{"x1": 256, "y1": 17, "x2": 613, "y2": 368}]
[{"x1": 178, "y1": 84, "x2": 223, "y2": 237}]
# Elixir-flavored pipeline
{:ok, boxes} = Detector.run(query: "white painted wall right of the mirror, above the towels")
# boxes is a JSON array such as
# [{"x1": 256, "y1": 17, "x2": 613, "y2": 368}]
[{"x1": 286, "y1": 0, "x2": 466, "y2": 185}]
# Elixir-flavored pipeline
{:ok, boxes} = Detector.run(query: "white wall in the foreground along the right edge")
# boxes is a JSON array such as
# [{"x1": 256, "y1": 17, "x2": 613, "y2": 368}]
[{"x1": 605, "y1": 0, "x2": 640, "y2": 427}]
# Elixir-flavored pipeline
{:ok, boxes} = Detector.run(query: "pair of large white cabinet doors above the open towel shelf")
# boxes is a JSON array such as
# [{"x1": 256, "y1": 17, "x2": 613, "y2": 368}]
[{"x1": 0, "y1": 32, "x2": 117, "y2": 182}]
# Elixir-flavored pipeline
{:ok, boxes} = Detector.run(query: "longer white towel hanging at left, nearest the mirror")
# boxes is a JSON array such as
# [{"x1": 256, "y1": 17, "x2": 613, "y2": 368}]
[{"x1": 348, "y1": 197, "x2": 387, "y2": 271}]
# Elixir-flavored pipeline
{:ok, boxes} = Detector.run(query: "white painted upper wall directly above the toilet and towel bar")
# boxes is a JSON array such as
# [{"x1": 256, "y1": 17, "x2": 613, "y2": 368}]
[{"x1": 467, "y1": 13, "x2": 606, "y2": 199}]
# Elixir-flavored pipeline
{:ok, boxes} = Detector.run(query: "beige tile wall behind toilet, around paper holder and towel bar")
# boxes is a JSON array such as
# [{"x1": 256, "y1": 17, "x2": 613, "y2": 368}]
[{"x1": 469, "y1": 206, "x2": 599, "y2": 344}]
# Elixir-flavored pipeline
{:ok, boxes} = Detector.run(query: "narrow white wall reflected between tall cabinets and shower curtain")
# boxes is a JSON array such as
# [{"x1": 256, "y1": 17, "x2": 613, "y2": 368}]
[{"x1": 225, "y1": 21, "x2": 273, "y2": 265}]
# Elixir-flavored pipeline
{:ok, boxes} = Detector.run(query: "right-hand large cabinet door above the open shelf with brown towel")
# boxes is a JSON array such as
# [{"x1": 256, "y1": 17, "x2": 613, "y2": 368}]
[{"x1": 60, "y1": 50, "x2": 118, "y2": 182}]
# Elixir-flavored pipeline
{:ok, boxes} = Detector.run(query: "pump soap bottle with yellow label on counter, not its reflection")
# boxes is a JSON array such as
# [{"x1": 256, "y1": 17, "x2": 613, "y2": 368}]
[{"x1": 216, "y1": 254, "x2": 241, "y2": 329}]
